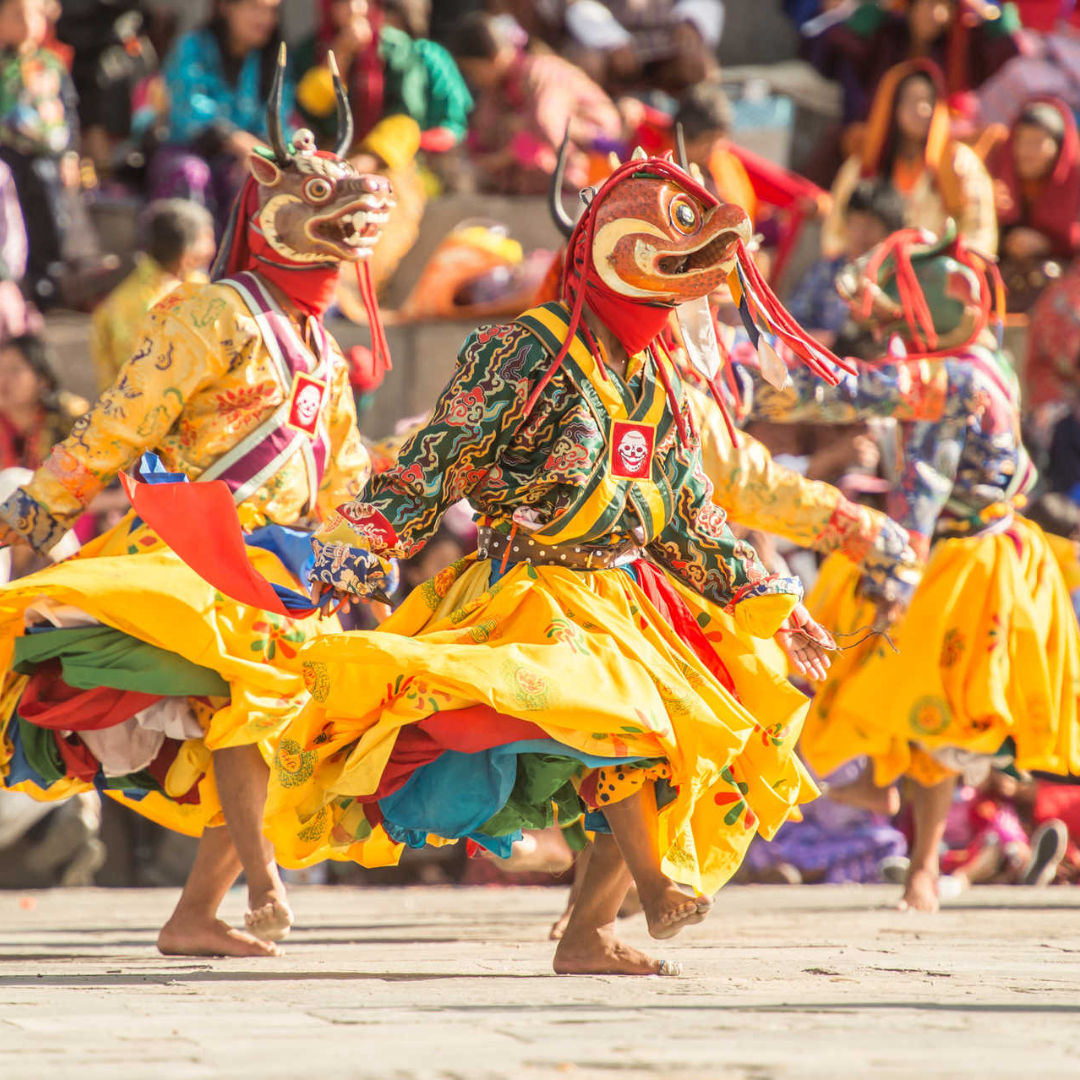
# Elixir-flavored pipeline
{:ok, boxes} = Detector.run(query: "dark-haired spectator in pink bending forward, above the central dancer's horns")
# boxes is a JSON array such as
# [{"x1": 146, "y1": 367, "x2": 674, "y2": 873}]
[{"x1": 450, "y1": 12, "x2": 622, "y2": 194}]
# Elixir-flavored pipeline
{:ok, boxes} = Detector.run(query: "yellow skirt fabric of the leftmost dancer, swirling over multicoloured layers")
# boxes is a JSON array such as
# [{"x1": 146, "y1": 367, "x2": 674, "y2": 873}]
[{"x1": 0, "y1": 514, "x2": 340, "y2": 836}]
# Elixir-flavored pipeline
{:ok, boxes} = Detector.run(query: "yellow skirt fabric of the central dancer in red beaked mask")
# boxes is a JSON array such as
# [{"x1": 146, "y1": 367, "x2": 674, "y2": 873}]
[{"x1": 267, "y1": 556, "x2": 816, "y2": 892}]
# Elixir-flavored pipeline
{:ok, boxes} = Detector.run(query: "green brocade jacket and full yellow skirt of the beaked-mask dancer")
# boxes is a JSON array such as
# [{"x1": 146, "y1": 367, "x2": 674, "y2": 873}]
[{"x1": 267, "y1": 305, "x2": 815, "y2": 892}]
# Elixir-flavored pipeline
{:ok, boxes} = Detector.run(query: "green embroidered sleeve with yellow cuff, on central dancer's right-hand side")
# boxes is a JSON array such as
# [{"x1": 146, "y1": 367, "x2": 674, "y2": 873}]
[{"x1": 649, "y1": 438, "x2": 802, "y2": 637}]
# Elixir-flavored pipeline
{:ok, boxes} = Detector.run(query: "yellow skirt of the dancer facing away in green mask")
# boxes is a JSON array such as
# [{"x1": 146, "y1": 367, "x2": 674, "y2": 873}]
[{"x1": 801, "y1": 518, "x2": 1080, "y2": 784}]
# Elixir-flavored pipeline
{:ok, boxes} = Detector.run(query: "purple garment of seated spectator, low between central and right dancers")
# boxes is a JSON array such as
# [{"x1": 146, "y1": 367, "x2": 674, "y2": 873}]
[{"x1": 745, "y1": 759, "x2": 907, "y2": 885}]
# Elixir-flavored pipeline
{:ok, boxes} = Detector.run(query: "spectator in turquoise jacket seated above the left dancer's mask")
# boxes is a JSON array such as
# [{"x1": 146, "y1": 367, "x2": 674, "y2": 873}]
[{"x1": 150, "y1": 0, "x2": 293, "y2": 229}]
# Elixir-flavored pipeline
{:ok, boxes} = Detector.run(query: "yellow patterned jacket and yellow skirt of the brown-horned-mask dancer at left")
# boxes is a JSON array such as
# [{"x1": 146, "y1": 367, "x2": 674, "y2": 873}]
[{"x1": 0, "y1": 285, "x2": 367, "y2": 835}]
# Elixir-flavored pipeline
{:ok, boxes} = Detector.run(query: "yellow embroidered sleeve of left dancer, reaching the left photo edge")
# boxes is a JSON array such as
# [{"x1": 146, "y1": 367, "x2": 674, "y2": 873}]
[{"x1": 0, "y1": 294, "x2": 227, "y2": 552}]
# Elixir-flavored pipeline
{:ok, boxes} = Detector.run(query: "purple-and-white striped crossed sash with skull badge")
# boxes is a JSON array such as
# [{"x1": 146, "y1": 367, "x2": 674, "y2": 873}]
[{"x1": 198, "y1": 271, "x2": 332, "y2": 510}]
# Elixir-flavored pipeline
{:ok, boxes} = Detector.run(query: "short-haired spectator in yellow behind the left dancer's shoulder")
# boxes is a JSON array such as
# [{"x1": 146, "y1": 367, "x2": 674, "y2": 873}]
[{"x1": 90, "y1": 199, "x2": 214, "y2": 390}]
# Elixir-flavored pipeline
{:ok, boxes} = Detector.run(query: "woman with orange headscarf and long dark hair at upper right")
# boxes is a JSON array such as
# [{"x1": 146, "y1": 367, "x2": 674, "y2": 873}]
[{"x1": 822, "y1": 60, "x2": 998, "y2": 257}]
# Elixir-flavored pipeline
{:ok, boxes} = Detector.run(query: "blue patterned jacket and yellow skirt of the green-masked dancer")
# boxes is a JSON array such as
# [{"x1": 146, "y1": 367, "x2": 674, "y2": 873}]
[{"x1": 725, "y1": 332, "x2": 1080, "y2": 784}]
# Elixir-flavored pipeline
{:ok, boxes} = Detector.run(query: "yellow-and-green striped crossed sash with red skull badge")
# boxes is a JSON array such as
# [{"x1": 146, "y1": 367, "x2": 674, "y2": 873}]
[{"x1": 515, "y1": 303, "x2": 693, "y2": 544}]
